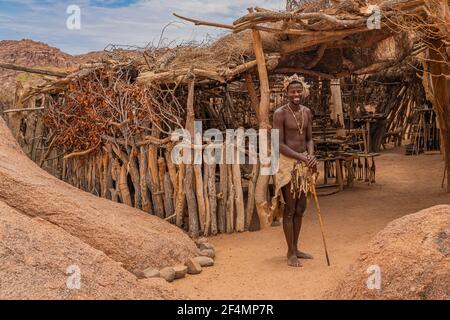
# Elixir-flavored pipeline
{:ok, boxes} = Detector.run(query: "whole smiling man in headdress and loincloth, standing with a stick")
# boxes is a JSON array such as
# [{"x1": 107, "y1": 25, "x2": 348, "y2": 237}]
[{"x1": 272, "y1": 75, "x2": 317, "y2": 267}]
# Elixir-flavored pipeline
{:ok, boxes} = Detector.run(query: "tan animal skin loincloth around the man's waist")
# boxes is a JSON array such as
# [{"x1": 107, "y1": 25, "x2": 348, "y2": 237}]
[{"x1": 270, "y1": 152, "x2": 318, "y2": 218}]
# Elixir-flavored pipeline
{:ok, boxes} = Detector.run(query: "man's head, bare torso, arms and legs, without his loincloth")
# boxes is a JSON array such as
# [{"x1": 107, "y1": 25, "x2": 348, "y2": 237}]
[{"x1": 273, "y1": 77, "x2": 317, "y2": 267}]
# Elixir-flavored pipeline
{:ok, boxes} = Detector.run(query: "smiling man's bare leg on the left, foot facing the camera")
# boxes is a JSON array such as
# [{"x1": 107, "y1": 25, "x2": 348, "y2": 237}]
[{"x1": 282, "y1": 185, "x2": 301, "y2": 267}]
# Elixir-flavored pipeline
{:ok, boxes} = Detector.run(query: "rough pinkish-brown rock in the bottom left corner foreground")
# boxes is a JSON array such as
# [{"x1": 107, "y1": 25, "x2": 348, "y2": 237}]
[{"x1": 0, "y1": 200, "x2": 184, "y2": 300}]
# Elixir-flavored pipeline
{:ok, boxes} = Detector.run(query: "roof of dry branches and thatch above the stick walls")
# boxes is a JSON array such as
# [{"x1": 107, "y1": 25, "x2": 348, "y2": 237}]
[{"x1": 14, "y1": 0, "x2": 449, "y2": 101}]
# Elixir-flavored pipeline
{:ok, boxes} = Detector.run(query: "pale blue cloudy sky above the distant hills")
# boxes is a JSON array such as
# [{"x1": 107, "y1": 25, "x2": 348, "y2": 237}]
[{"x1": 0, "y1": 0, "x2": 285, "y2": 54}]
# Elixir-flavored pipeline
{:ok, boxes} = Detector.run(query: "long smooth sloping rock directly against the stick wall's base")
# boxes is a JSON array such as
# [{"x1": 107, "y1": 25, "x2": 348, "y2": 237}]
[{"x1": 0, "y1": 118, "x2": 197, "y2": 271}]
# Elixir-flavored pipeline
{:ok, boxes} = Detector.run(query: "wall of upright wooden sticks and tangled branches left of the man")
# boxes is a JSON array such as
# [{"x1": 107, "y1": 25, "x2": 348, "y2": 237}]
[{"x1": 12, "y1": 59, "x2": 258, "y2": 237}]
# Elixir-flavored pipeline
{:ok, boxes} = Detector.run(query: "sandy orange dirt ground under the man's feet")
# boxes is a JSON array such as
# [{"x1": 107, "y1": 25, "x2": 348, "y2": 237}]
[{"x1": 174, "y1": 148, "x2": 450, "y2": 300}]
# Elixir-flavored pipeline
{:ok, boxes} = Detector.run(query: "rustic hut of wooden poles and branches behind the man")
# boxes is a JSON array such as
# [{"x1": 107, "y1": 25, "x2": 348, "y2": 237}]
[{"x1": 1, "y1": 0, "x2": 450, "y2": 237}]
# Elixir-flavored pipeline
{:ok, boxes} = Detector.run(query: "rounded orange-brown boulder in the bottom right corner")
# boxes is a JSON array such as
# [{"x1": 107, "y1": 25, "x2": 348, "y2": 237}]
[{"x1": 330, "y1": 205, "x2": 450, "y2": 299}]
